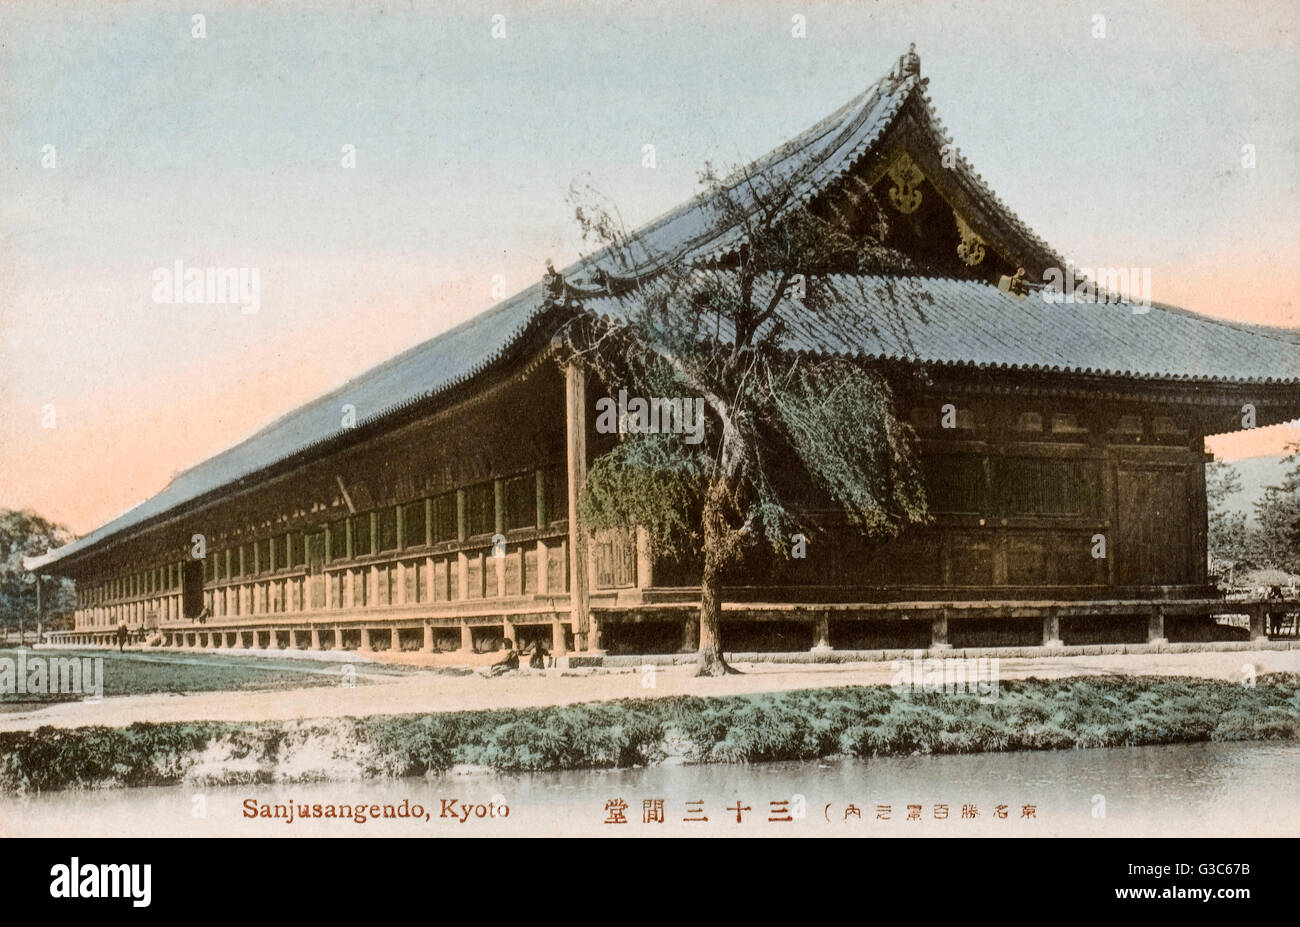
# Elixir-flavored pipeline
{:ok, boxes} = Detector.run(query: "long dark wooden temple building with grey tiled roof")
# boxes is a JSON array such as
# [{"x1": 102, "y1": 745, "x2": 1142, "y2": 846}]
[{"x1": 27, "y1": 53, "x2": 1300, "y2": 658}]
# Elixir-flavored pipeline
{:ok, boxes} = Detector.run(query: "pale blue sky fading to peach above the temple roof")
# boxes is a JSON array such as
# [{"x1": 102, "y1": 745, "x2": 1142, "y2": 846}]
[{"x1": 0, "y1": 0, "x2": 1300, "y2": 533}]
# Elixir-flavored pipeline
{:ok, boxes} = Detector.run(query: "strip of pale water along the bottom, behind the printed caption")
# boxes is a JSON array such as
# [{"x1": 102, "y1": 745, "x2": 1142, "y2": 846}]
[{"x1": 0, "y1": 742, "x2": 1300, "y2": 837}]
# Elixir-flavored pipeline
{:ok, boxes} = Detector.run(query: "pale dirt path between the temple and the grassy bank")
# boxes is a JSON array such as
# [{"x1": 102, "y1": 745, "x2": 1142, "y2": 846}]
[{"x1": 0, "y1": 650, "x2": 1300, "y2": 731}]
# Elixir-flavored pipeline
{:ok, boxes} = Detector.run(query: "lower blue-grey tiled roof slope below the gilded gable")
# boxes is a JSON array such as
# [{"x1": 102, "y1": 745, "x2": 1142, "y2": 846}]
[{"x1": 585, "y1": 276, "x2": 1300, "y2": 387}]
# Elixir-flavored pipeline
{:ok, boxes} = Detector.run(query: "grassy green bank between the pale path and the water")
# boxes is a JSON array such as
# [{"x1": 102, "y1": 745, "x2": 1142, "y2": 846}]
[{"x1": 0, "y1": 673, "x2": 1300, "y2": 792}]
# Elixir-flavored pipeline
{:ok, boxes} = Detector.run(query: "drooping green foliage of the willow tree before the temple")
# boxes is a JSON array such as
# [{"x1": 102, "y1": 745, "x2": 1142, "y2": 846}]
[{"x1": 566, "y1": 155, "x2": 926, "y2": 582}]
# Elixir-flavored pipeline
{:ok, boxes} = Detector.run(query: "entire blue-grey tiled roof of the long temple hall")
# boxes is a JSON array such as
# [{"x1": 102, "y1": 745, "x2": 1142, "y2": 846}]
[{"x1": 27, "y1": 52, "x2": 1300, "y2": 569}]
